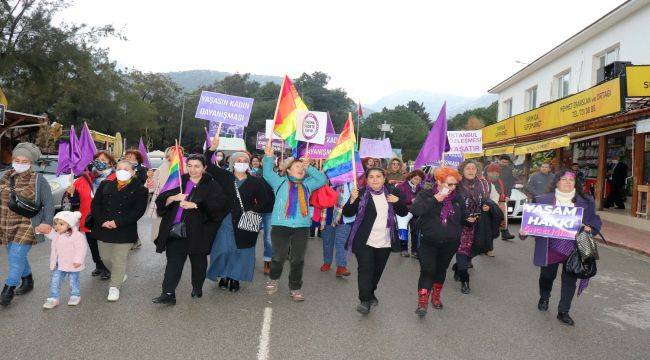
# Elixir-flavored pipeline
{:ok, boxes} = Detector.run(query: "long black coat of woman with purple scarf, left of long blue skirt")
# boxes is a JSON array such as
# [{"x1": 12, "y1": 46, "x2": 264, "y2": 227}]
[{"x1": 154, "y1": 174, "x2": 229, "y2": 254}]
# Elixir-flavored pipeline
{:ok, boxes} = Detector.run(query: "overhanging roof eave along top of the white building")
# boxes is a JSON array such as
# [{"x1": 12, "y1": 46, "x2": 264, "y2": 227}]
[{"x1": 488, "y1": 0, "x2": 650, "y2": 94}]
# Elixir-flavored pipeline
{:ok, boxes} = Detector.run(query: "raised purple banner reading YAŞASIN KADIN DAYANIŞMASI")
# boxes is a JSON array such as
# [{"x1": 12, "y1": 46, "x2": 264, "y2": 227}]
[{"x1": 194, "y1": 91, "x2": 253, "y2": 126}]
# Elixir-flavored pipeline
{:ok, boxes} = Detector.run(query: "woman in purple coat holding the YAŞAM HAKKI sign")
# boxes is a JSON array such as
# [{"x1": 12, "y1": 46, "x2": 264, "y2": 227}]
[{"x1": 519, "y1": 170, "x2": 602, "y2": 326}]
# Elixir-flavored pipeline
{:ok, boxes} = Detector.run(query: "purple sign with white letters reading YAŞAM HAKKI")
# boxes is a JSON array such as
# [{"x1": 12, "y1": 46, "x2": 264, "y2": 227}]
[{"x1": 521, "y1": 203, "x2": 584, "y2": 240}]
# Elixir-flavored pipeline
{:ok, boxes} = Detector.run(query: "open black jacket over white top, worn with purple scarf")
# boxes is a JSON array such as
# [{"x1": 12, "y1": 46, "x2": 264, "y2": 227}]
[{"x1": 343, "y1": 185, "x2": 408, "y2": 253}]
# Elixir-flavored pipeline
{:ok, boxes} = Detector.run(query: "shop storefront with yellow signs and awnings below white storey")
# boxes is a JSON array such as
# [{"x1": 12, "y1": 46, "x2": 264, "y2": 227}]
[{"x1": 476, "y1": 66, "x2": 650, "y2": 216}]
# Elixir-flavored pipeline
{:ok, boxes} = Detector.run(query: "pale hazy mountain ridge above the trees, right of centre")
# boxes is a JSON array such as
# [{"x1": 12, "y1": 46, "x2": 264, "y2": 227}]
[{"x1": 368, "y1": 90, "x2": 498, "y2": 119}]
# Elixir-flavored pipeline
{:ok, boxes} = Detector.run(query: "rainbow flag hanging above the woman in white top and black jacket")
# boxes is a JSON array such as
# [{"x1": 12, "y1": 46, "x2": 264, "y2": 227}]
[{"x1": 323, "y1": 113, "x2": 363, "y2": 186}]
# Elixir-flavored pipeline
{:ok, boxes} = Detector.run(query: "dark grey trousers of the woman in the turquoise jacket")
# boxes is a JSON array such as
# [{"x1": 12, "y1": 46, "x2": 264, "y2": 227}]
[{"x1": 269, "y1": 226, "x2": 309, "y2": 290}]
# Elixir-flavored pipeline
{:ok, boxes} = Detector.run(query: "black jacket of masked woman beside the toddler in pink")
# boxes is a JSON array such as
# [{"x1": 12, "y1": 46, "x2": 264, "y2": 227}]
[{"x1": 90, "y1": 177, "x2": 148, "y2": 244}]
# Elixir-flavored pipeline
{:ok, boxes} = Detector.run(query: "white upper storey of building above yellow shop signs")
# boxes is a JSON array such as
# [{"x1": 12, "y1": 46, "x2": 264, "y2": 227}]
[{"x1": 489, "y1": 0, "x2": 650, "y2": 121}]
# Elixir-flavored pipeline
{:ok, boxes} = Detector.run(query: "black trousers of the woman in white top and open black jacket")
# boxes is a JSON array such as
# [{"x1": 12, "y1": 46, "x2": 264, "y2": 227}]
[{"x1": 354, "y1": 244, "x2": 391, "y2": 301}]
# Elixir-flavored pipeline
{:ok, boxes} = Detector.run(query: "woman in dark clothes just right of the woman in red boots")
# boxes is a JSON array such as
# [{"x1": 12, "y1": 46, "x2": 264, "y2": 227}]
[{"x1": 452, "y1": 160, "x2": 503, "y2": 294}]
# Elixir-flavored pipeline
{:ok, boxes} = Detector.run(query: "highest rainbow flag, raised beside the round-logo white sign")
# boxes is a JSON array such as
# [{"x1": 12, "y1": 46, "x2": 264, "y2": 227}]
[{"x1": 273, "y1": 75, "x2": 308, "y2": 149}]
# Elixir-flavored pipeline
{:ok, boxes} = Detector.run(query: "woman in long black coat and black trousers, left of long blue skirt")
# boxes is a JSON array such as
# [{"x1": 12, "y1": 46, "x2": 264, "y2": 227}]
[{"x1": 153, "y1": 155, "x2": 228, "y2": 305}]
